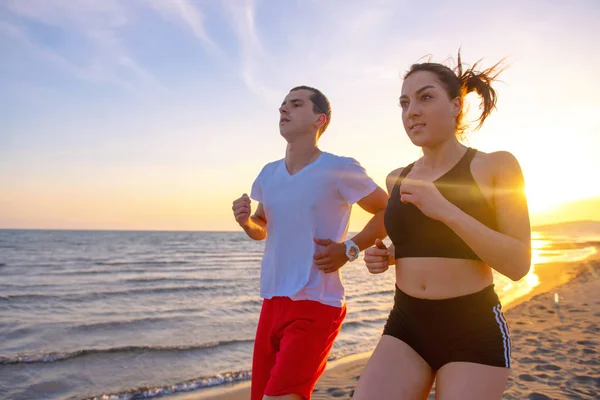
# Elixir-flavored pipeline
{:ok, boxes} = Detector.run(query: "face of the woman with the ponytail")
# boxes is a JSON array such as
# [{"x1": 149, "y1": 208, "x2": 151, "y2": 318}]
[{"x1": 400, "y1": 71, "x2": 461, "y2": 147}]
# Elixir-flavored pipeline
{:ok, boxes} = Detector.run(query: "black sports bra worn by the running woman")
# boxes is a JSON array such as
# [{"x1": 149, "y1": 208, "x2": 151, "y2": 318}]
[{"x1": 384, "y1": 148, "x2": 497, "y2": 260}]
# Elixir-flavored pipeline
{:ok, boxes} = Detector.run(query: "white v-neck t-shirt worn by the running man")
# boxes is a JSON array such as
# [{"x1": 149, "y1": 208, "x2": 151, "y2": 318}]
[{"x1": 251, "y1": 152, "x2": 377, "y2": 307}]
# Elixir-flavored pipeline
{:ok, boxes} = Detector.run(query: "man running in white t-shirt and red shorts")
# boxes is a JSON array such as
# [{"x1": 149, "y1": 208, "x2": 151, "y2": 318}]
[{"x1": 233, "y1": 86, "x2": 387, "y2": 400}]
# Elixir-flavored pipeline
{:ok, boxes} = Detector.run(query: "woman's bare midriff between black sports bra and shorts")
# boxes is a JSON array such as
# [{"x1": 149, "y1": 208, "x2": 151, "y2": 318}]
[{"x1": 396, "y1": 258, "x2": 494, "y2": 299}]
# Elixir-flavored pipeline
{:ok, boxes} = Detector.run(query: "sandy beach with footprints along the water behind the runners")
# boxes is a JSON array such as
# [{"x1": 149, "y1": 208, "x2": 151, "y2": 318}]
[{"x1": 176, "y1": 256, "x2": 600, "y2": 400}]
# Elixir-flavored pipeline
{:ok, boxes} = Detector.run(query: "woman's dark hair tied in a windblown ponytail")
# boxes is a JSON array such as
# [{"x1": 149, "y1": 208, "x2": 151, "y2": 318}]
[{"x1": 404, "y1": 50, "x2": 504, "y2": 136}]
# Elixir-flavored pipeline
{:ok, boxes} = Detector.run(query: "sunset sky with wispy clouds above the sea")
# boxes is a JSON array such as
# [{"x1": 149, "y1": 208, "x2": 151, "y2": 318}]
[{"x1": 0, "y1": 0, "x2": 600, "y2": 230}]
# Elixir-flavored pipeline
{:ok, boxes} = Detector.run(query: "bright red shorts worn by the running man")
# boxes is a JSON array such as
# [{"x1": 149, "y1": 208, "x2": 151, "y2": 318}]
[{"x1": 251, "y1": 297, "x2": 346, "y2": 400}]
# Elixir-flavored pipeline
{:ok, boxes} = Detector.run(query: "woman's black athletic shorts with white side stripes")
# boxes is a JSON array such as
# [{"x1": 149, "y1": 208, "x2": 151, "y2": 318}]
[{"x1": 383, "y1": 285, "x2": 510, "y2": 370}]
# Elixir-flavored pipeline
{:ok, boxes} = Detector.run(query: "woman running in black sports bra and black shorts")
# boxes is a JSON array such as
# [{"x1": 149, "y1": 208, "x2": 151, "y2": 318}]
[{"x1": 354, "y1": 53, "x2": 531, "y2": 400}]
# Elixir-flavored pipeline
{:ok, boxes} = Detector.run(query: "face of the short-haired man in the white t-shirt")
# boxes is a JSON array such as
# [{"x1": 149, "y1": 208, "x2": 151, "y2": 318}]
[{"x1": 279, "y1": 89, "x2": 326, "y2": 141}]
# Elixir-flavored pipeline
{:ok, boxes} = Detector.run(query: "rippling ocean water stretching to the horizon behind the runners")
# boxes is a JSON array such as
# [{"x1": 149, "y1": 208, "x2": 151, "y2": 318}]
[{"x1": 0, "y1": 223, "x2": 600, "y2": 400}]
